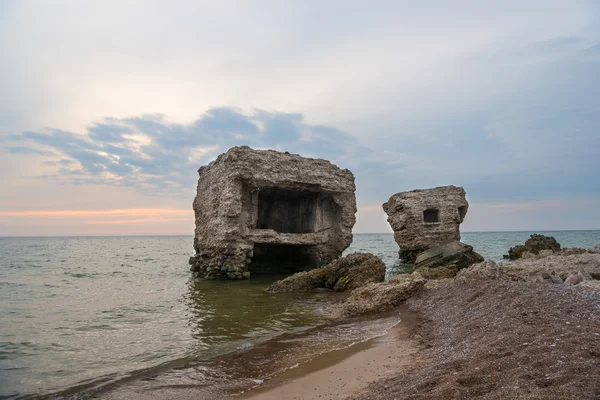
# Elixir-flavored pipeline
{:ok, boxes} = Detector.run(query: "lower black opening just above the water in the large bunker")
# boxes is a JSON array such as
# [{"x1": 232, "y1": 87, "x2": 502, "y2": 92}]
[{"x1": 249, "y1": 243, "x2": 316, "y2": 275}]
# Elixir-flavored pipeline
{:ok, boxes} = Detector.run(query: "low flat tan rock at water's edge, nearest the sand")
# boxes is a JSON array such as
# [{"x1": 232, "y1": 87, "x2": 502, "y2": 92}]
[{"x1": 334, "y1": 273, "x2": 427, "y2": 317}]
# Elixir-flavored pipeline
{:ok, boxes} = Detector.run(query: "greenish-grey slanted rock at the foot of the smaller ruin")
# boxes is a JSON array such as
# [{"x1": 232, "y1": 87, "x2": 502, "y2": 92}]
[{"x1": 415, "y1": 241, "x2": 484, "y2": 276}]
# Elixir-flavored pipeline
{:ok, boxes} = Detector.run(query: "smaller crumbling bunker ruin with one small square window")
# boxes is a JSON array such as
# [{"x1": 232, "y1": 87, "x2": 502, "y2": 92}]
[{"x1": 383, "y1": 186, "x2": 469, "y2": 264}]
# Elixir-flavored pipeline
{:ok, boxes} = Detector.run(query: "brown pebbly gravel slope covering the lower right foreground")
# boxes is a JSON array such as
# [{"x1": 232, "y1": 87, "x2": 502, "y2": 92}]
[{"x1": 352, "y1": 281, "x2": 600, "y2": 400}]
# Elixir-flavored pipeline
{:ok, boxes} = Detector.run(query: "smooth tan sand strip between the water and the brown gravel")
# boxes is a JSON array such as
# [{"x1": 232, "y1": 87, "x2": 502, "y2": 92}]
[{"x1": 237, "y1": 307, "x2": 424, "y2": 400}]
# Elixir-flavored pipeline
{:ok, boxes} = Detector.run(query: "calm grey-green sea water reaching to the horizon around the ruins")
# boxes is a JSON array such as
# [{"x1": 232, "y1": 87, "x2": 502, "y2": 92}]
[{"x1": 0, "y1": 231, "x2": 600, "y2": 399}]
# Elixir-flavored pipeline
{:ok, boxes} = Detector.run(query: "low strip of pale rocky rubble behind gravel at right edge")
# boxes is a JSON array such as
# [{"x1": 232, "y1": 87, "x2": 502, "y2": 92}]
[{"x1": 456, "y1": 252, "x2": 600, "y2": 285}]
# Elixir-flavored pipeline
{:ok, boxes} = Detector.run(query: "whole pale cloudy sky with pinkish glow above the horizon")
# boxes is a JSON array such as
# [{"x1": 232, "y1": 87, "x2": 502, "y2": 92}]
[{"x1": 0, "y1": 0, "x2": 600, "y2": 236}]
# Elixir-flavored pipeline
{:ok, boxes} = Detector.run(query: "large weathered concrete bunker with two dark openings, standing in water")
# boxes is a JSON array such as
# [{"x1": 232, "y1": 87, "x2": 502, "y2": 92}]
[{"x1": 190, "y1": 146, "x2": 356, "y2": 279}]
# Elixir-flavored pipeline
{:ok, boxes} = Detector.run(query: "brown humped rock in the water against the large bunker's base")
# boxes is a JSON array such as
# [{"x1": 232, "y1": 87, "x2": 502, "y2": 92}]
[{"x1": 268, "y1": 253, "x2": 385, "y2": 293}]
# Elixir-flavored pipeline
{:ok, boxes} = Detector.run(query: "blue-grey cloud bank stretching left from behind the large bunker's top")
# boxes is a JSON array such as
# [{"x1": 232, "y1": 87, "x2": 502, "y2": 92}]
[{"x1": 7, "y1": 107, "x2": 357, "y2": 196}]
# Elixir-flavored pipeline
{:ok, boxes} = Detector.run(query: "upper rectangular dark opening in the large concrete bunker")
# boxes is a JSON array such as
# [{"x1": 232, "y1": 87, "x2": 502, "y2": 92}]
[{"x1": 256, "y1": 188, "x2": 317, "y2": 233}]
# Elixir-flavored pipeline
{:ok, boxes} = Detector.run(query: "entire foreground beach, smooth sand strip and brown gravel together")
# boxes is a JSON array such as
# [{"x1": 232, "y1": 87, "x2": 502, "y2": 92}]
[{"x1": 232, "y1": 281, "x2": 600, "y2": 400}]
